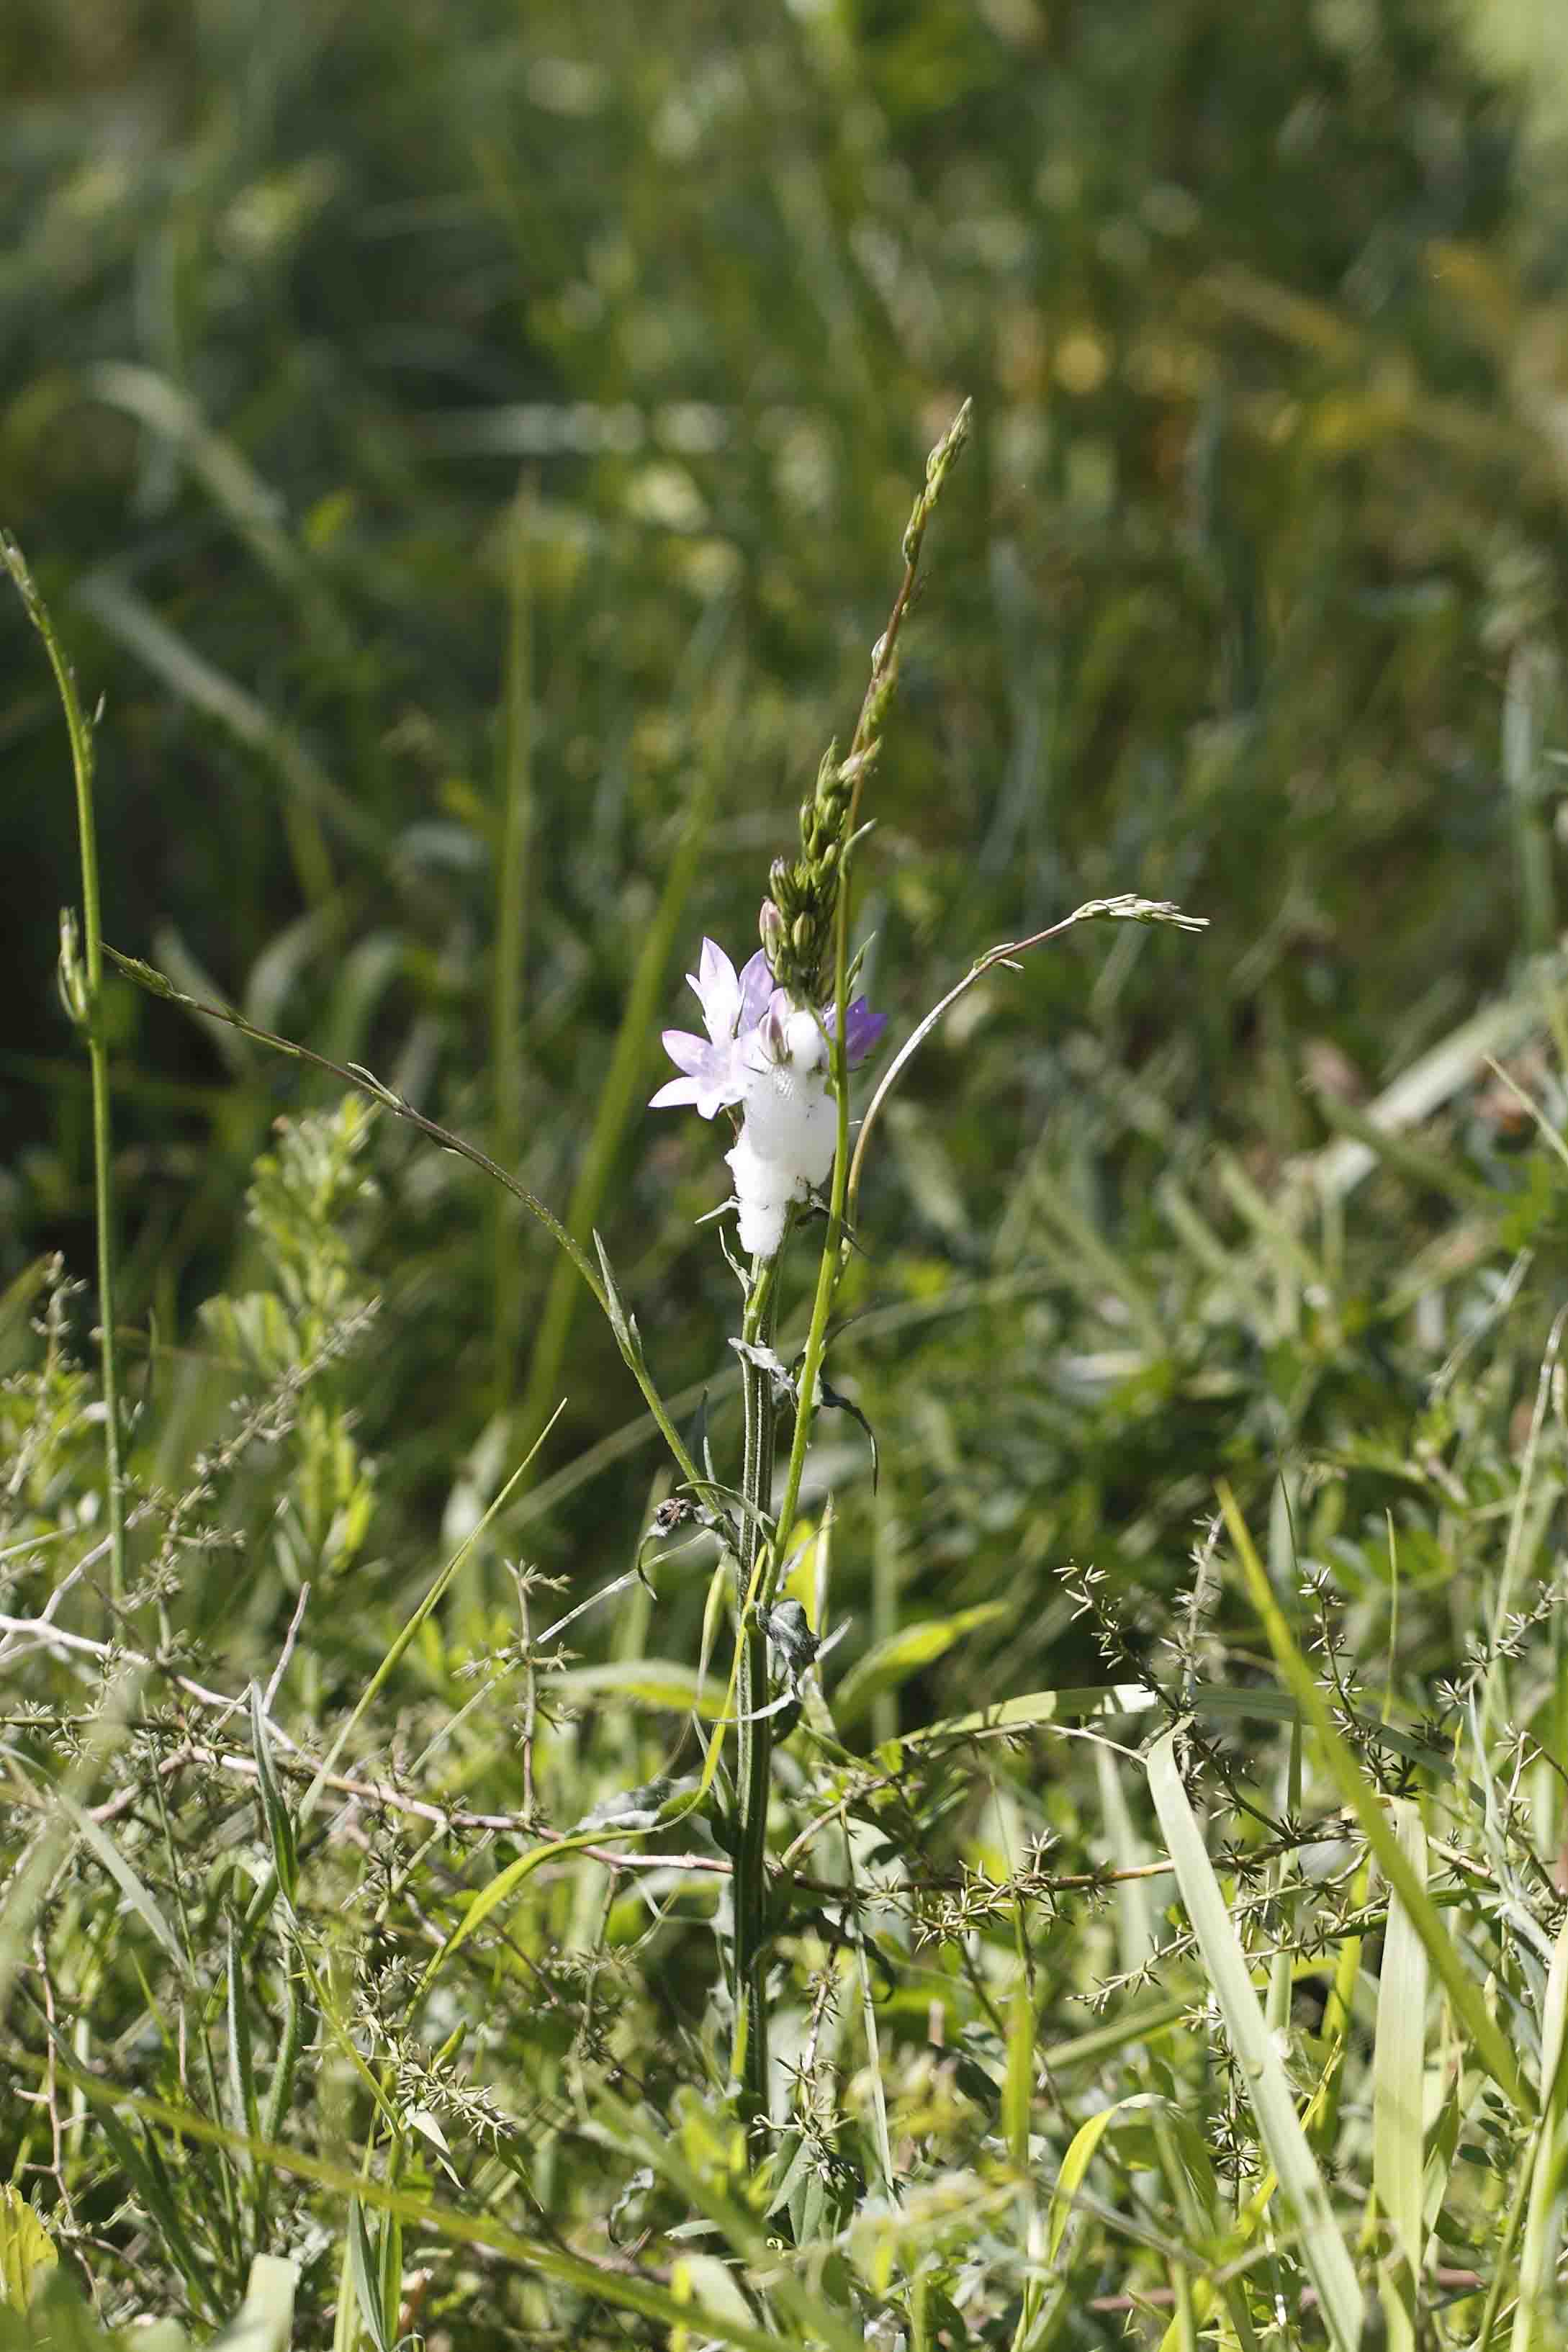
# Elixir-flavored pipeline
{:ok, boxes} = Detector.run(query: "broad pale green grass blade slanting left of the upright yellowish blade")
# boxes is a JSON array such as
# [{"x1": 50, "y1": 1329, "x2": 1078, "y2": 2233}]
[{"x1": 1150, "y1": 1731, "x2": 1361, "y2": 2352}]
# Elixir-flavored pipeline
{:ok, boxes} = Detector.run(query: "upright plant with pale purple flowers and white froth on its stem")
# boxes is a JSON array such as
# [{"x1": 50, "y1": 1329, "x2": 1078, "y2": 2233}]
[{"x1": 652, "y1": 405, "x2": 1192, "y2": 2164}]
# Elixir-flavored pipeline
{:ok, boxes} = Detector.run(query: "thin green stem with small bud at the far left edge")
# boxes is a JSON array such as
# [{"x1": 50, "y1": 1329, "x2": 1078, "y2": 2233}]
[{"x1": 0, "y1": 534, "x2": 125, "y2": 1602}]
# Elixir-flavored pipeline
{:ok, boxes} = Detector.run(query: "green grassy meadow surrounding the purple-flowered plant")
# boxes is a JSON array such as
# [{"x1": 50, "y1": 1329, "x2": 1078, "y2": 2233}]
[{"x1": 0, "y1": 0, "x2": 1568, "y2": 2352}]
